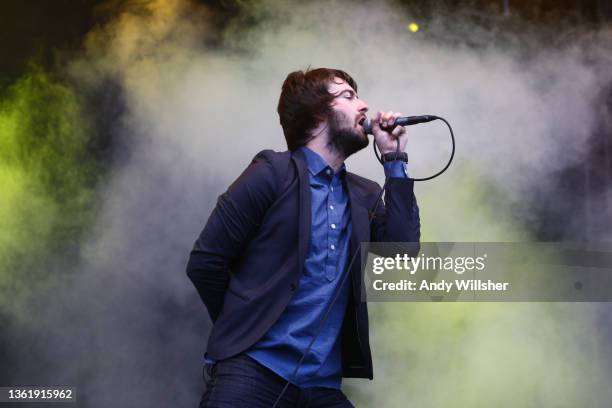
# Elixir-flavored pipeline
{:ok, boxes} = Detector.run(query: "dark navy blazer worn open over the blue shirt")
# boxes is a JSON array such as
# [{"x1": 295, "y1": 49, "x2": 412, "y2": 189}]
[{"x1": 187, "y1": 150, "x2": 420, "y2": 379}]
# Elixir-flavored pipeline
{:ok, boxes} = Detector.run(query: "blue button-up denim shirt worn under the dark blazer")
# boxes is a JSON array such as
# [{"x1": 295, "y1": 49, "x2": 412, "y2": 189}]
[{"x1": 207, "y1": 147, "x2": 407, "y2": 389}]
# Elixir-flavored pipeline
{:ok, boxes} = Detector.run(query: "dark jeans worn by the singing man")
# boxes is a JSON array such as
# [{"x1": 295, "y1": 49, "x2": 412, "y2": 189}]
[{"x1": 200, "y1": 354, "x2": 354, "y2": 408}]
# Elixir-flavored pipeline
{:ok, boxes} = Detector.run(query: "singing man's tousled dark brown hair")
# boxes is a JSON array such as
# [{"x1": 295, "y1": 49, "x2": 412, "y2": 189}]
[{"x1": 277, "y1": 68, "x2": 357, "y2": 150}]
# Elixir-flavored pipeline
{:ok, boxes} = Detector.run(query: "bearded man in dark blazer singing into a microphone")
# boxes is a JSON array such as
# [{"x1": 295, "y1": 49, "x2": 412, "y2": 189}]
[{"x1": 187, "y1": 68, "x2": 420, "y2": 408}]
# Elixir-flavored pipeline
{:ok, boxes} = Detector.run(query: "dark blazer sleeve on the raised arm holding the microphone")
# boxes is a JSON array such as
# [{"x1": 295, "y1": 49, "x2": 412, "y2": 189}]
[{"x1": 371, "y1": 177, "x2": 421, "y2": 256}]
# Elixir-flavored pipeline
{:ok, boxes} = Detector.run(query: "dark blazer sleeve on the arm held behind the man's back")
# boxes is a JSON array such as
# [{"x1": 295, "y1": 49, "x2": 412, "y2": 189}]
[{"x1": 187, "y1": 150, "x2": 278, "y2": 322}]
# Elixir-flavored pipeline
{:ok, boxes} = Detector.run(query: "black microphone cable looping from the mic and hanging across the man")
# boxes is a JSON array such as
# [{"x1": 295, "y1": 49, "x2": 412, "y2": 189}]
[{"x1": 272, "y1": 115, "x2": 455, "y2": 408}]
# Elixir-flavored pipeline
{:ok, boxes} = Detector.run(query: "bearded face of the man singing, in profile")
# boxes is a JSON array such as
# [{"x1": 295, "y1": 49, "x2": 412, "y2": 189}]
[{"x1": 327, "y1": 77, "x2": 369, "y2": 157}]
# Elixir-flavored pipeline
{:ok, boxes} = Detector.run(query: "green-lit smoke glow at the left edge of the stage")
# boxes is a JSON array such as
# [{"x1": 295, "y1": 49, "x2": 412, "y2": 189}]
[{"x1": 0, "y1": 69, "x2": 96, "y2": 312}]
